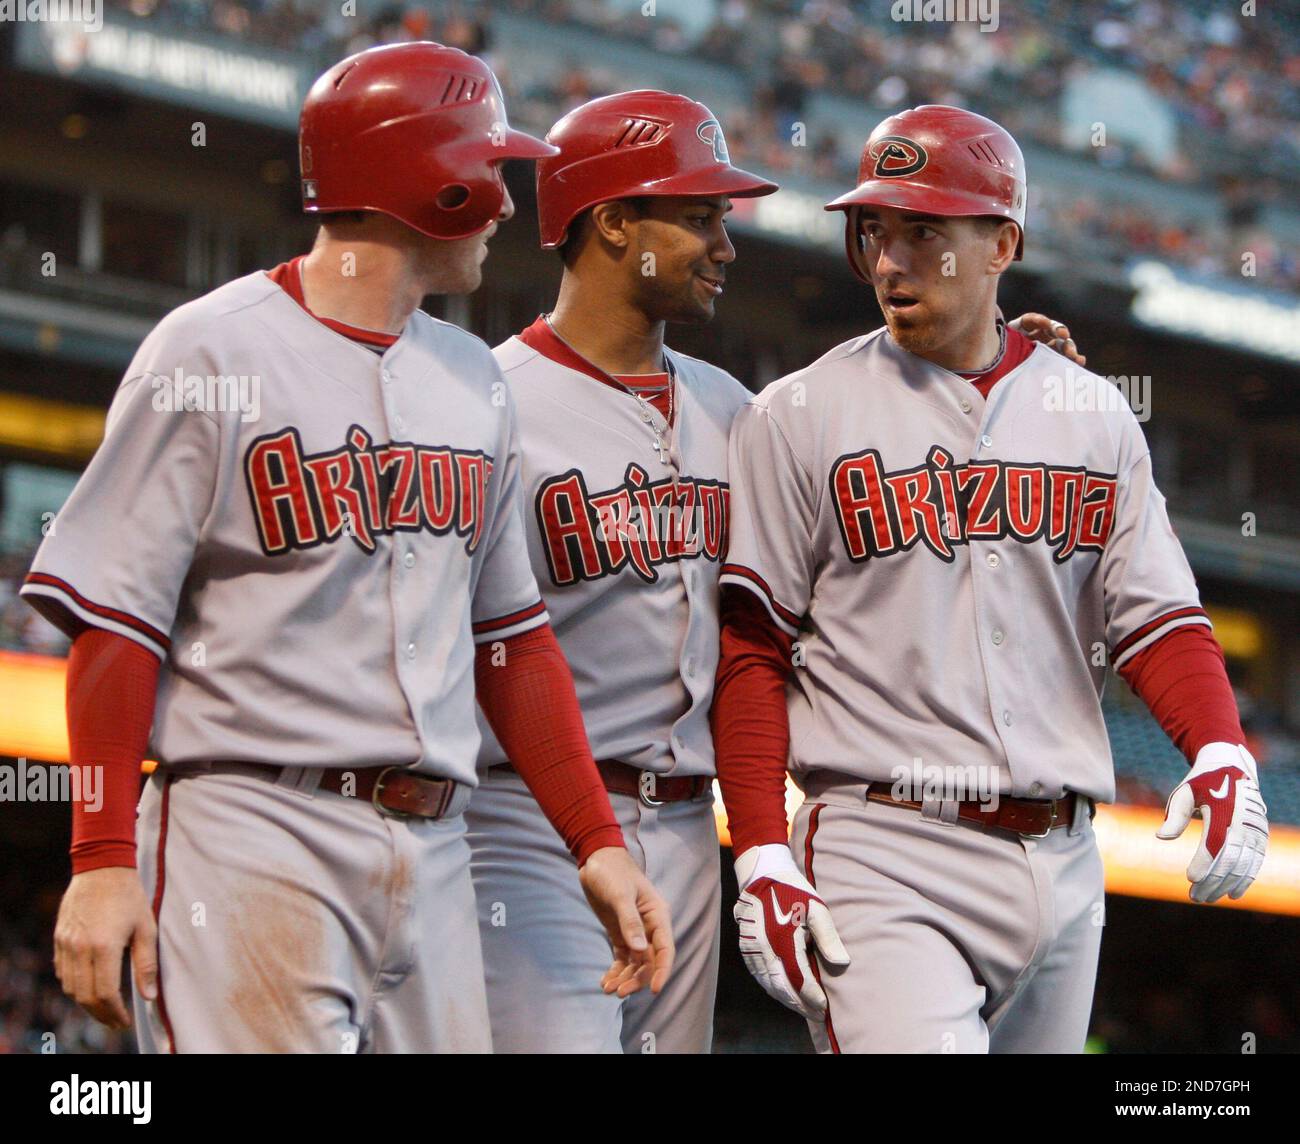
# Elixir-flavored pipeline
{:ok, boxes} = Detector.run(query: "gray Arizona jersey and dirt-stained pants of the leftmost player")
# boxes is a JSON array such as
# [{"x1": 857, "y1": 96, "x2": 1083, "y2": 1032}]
[{"x1": 23, "y1": 274, "x2": 546, "y2": 1052}]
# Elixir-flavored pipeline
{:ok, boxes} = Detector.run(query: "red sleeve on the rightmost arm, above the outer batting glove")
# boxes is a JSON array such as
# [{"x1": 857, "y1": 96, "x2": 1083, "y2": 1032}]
[{"x1": 1119, "y1": 624, "x2": 1245, "y2": 762}]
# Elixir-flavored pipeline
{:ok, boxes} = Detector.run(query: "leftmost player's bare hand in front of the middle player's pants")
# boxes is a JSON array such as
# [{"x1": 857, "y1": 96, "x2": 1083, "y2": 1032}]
[{"x1": 579, "y1": 846, "x2": 676, "y2": 997}]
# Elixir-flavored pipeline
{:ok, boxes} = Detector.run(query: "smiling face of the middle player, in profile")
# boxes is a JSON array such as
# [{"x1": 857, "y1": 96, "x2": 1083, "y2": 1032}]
[{"x1": 628, "y1": 195, "x2": 736, "y2": 322}]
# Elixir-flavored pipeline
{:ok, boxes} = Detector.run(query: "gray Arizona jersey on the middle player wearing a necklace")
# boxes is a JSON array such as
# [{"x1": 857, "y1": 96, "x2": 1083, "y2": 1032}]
[{"x1": 480, "y1": 338, "x2": 750, "y2": 775}]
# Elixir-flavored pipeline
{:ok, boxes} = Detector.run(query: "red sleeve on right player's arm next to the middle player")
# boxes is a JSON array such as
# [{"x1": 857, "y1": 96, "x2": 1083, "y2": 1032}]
[{"x1": 710, "y1": 585, "x2": 794, "y2": 857}]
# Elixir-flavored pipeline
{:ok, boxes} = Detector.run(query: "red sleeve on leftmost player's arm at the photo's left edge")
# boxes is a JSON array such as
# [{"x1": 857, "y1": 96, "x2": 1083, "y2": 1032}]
[{"x1": 68, "y1": 628, "x2": 159, "y2": 874}]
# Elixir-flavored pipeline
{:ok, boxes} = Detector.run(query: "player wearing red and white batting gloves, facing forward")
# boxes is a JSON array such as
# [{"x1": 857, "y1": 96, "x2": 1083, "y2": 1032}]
[{"x1": 712, "y1": 107, "x2": 1268, "y2": 1052}]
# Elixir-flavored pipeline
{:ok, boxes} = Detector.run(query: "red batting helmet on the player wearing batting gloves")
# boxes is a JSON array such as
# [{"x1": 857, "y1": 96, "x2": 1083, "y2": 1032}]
[{"x1": 826, "y1": 104, "x2": 1026, "y2": 281}]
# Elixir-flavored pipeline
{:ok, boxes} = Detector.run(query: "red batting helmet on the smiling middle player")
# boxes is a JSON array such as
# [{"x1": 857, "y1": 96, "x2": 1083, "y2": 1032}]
[{"x1": 537, "y1": 91, "x2": 776, "y2": 248}]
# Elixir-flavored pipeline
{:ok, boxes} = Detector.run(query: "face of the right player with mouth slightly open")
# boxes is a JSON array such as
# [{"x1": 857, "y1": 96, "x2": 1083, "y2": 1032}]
[{"x1": 857, "y1": 207, "x2": 1011, "y2": 355}]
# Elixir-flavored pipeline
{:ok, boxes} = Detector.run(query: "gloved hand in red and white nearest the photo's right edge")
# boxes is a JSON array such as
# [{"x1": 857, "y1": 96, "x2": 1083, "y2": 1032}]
[{"x1": 1156, "y1": 742, "x2": 1269, "y2": 902}]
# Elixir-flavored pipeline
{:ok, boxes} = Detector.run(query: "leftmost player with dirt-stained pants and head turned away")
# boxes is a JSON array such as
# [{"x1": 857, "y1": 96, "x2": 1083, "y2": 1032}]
[{"x1": 22, "y1": 43, "x2": 672, "y2": 1052}]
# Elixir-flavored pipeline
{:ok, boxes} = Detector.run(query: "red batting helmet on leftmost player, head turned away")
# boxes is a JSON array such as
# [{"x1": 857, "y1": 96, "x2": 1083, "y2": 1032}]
[{"x1": 298, "y1": 42, "x2": 555, "y2": 239}]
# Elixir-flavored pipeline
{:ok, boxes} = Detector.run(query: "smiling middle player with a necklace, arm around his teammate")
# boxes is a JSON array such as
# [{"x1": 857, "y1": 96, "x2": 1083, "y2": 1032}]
[{"x1": 467, "y1": 91, "x2": 1097, "y2": 1052}]
